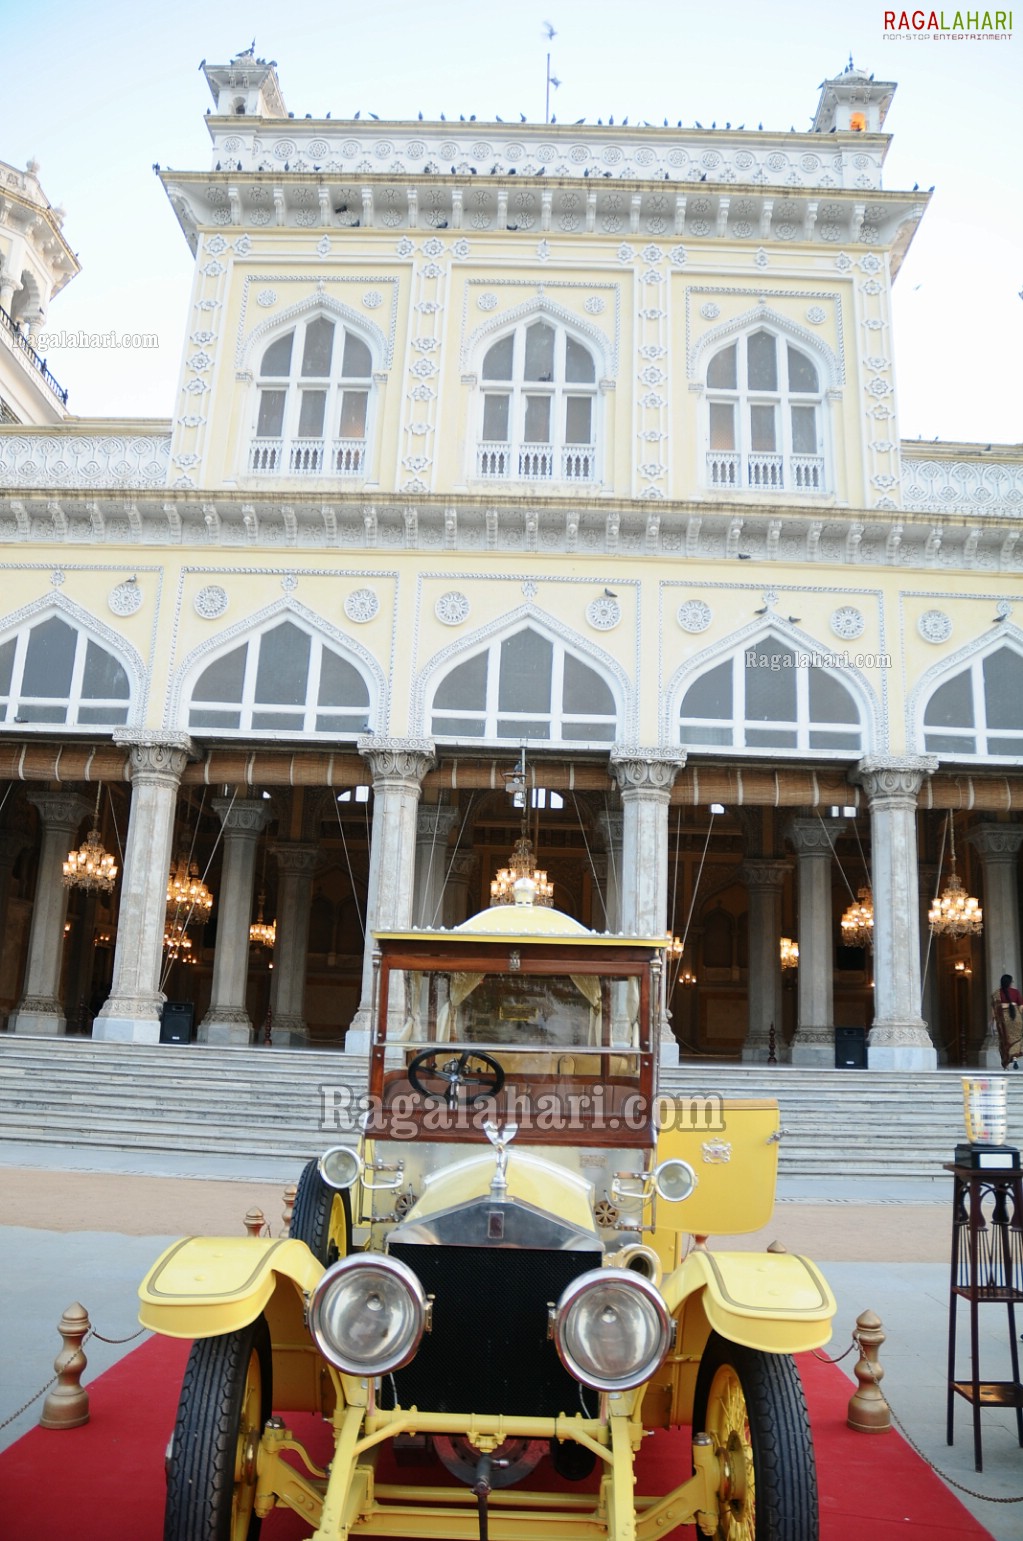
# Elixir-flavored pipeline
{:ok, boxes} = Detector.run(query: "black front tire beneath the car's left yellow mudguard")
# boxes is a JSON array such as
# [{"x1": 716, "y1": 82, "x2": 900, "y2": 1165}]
[{"x1": 163, "y1": 1316, "x2": 271, "y2": 1541}]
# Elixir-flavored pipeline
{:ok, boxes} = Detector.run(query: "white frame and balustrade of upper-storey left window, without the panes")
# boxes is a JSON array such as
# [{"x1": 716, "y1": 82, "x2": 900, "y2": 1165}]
[{"x1": 245, "y1": 310, "x2": 376, "y2": 481}]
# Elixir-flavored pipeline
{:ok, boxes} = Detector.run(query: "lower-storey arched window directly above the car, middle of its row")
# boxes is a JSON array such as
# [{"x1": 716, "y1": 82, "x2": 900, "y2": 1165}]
[{"x1": 430, "y1": 626, "x2": 618, "y2": 743}]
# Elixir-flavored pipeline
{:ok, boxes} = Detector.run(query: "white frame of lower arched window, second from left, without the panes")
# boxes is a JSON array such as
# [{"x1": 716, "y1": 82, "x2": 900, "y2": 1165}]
[{"x1": 185, "y1": 615, "x2": 376, "y2": 740}]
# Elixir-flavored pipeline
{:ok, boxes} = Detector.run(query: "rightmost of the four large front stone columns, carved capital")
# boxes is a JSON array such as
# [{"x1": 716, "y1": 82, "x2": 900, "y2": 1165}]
[{"x1": 850, "y1": 755, "x2": 938, "y2": 1069}]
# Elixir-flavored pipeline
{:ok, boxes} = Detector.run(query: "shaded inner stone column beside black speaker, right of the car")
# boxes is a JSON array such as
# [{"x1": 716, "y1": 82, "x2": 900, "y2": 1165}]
[{"x1": 789, "y1": 817, "x2": 846, "y2": 1069}]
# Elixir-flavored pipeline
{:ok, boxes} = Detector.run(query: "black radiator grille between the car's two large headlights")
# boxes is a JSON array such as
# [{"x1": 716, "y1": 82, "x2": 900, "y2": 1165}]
[{"x1": 388, "y1": 1242, "x2": 601, "y2": 1418}]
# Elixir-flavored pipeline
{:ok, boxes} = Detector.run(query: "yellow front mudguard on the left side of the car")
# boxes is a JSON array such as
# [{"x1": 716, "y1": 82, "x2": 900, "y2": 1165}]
[{"x1": 139, "y1": 1236, "x2": 324, "y2": 1338}]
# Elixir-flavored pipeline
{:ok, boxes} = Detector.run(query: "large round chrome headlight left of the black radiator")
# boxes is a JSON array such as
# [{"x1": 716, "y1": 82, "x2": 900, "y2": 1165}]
[{"x1": 310, "y1": 1253, "x2": 428, "y2": 1378}]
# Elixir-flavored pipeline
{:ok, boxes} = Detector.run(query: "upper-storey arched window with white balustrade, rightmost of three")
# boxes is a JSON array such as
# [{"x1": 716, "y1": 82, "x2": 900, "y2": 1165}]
[{"x1": 707, "y1": 328, "x2": 827, "y2": 493}]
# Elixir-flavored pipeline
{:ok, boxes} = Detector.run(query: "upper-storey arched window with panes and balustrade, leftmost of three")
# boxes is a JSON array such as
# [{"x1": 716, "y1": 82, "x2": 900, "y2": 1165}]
[{"x1": 248, "y1": 316, "x2": 373, "y2": 476}]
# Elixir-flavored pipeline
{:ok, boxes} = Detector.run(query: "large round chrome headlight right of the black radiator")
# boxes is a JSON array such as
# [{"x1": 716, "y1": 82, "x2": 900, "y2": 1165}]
[{"x1": 555, "y1": 1268, "x2": 673, "y2": 1392}]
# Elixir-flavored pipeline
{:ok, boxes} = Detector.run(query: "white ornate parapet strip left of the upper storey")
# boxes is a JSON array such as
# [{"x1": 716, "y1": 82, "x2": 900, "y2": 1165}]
[{"x1": 0, "y1": 427, "x2": 171, "y2": 488}]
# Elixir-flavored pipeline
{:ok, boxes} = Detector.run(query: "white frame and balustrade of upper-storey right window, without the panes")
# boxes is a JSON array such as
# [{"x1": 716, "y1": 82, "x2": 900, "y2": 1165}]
[{"x1": 703, "y1": 324, "x2": 832, "y2": 498}]
